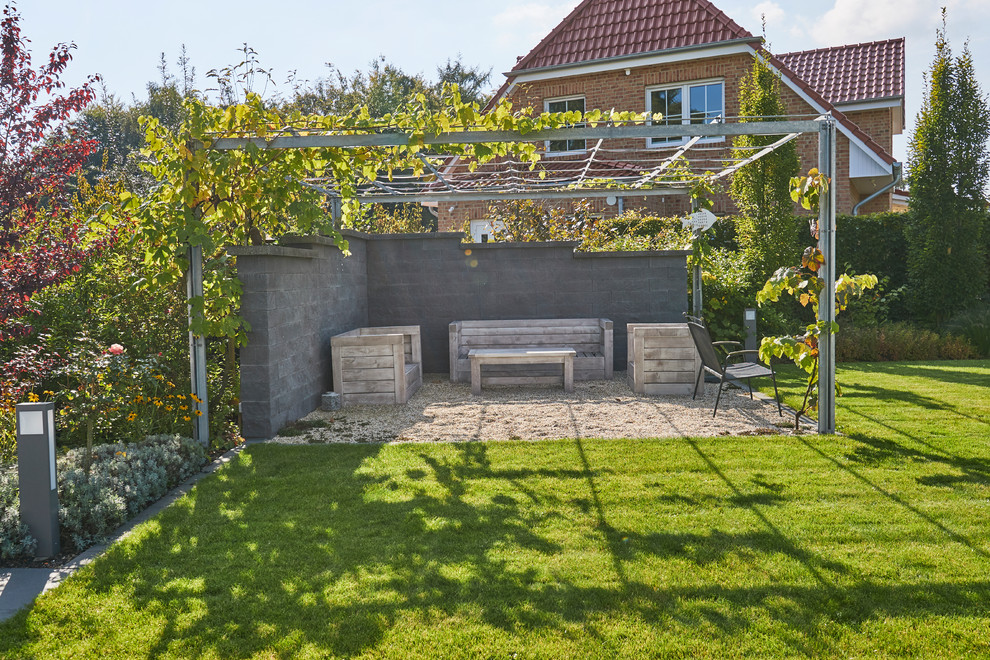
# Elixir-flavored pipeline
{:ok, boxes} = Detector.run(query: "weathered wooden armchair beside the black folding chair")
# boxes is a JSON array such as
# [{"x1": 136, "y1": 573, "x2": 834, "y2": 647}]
[{"x1": 626, "y1": 323, "x2": 701, "y2": 395}]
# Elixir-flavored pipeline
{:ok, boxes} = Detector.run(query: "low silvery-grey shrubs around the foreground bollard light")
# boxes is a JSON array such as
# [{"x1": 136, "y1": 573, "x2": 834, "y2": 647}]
[{"x1": 0, "y1": 435, "x2": 207, "y2": 558}]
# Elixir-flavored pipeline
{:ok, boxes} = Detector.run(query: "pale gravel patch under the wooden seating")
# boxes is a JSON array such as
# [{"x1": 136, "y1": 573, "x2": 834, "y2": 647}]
[{"x1": 273, "y1": 372, "x2": 793, "y2": 444}]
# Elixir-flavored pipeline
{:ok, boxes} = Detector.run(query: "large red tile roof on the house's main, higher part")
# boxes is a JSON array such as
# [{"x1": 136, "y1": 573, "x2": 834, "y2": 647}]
[{"x1": 512, "y1": 0, "x2": 758, "y2": 73}]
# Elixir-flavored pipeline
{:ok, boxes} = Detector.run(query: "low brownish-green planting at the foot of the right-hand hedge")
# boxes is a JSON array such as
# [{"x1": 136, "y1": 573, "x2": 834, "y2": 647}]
[{"x1": 835, "y1": 323, "x2": 975, "y2": 362}]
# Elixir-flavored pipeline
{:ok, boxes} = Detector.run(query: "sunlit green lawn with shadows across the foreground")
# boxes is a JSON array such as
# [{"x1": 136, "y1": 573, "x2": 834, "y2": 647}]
[{"x1": 0, "y1": 361, "x2": 990, "y2": 658}]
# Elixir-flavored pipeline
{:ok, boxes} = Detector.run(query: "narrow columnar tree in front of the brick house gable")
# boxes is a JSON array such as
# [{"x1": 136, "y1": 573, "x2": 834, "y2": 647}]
[{"x1": 729, "y1": 57, "x2": 800, "y2": 283}]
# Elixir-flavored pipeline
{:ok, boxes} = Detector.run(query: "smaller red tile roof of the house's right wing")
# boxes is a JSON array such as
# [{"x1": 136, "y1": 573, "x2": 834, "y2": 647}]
[{"x1": 777, "y1": 37, "x2": 904, "y2": 103}]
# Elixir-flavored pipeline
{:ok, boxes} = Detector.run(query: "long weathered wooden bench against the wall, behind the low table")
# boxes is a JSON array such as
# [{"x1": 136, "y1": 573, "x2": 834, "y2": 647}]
[{"x1": 450, "y1": 318, "x2": 612, "y2": 385}]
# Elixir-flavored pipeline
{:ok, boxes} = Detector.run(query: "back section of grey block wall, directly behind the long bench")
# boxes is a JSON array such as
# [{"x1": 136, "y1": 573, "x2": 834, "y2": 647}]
[{"x1": 368, "y1": 234, "x2": 687, "y2": 373}]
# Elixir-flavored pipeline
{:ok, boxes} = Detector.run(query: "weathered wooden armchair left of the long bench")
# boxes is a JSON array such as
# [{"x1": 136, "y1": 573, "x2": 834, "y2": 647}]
[{"x1": 330, "y1": 325, "x2": 423, "y2": 406}]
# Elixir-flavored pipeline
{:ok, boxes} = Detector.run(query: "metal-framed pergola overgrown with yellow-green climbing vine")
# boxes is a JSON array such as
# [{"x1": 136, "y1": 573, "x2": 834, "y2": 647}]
[{"x1": 131, "y1": 92, "x2": 836, "y2": 442}]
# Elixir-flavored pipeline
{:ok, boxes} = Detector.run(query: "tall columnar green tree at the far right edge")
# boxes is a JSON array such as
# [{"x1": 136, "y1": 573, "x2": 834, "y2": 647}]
[{"x1": 906, "y1": 10, "x2": 990, "y2": 325}]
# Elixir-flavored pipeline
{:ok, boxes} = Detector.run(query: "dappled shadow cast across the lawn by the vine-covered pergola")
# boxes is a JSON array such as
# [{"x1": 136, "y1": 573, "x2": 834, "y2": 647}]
[{"x1": 0, "y1": 441, "x2": 990, "y2": 657}]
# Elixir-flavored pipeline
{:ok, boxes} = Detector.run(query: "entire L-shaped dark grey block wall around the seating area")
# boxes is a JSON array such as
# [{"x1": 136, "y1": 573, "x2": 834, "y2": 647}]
[{"x1": 238, "y1": 231, "x2": 687, "y2": 437}]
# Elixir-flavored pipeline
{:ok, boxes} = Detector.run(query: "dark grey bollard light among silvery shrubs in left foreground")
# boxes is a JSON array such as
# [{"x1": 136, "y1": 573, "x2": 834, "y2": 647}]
[{"x1": 15, "y1": 402, "x2": 61, "y2": 557}]
